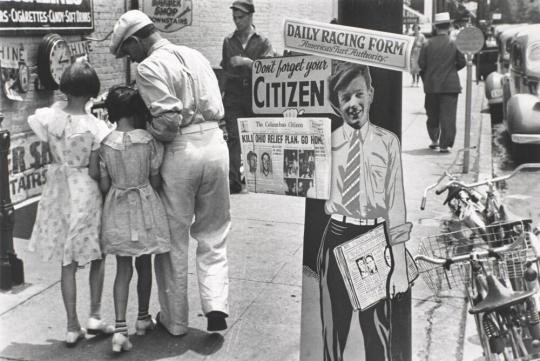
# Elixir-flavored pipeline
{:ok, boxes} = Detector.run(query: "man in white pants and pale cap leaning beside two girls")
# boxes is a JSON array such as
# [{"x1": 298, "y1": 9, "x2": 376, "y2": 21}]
[{"x1": 110, "y1": 10, "x2": 231, "y2": 335}]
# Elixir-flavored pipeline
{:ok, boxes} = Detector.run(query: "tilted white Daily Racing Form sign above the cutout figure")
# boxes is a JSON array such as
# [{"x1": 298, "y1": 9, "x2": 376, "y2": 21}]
[{"x1": 283, "y1": 19, "x2": 414, "y2": 71}]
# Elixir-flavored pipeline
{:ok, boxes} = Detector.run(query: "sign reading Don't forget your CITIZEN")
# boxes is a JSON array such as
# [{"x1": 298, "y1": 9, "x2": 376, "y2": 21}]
[{"x1": 252, "y1": 55, "x2": 333, "y2": 114}]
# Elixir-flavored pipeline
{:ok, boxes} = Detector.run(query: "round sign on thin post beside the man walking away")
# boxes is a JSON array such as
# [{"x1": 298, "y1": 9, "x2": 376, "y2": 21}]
[{"x1": 456, "y1": 26, "x2": 484, "y2": 173}]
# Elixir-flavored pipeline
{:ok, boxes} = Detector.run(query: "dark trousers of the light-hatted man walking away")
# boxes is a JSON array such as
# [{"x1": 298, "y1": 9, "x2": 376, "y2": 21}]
[{"x1": 424, "y1": 93, "x2": 458, "y2": 148}]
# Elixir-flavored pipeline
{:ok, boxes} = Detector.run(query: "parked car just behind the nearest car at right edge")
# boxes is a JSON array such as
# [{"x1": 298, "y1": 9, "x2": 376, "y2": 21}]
[{"x1": 484, "y1": 24, "x2": 527, "y2": 124}]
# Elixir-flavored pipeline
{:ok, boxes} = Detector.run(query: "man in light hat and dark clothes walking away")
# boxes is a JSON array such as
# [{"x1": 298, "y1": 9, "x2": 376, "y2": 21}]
[{"x1": 418, "y1": 12, "x2": 466, "y2": 153}]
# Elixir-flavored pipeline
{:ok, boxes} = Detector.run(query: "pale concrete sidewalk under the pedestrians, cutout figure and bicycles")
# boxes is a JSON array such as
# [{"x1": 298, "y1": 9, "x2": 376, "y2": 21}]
[{"x1": 0, "y1": 68, "x2": 489, "y2": 361}]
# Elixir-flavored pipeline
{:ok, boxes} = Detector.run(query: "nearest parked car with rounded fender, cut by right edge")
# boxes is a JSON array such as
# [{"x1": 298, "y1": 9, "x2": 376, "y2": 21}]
[{"x1": 503, "y1": 24, "x2": 540, "y2": 157}]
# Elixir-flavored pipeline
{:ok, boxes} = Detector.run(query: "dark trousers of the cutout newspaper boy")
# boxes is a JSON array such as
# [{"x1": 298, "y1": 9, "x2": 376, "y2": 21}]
[{"x1": 317, "y1": 219, "x2": 411, "y2": 361}]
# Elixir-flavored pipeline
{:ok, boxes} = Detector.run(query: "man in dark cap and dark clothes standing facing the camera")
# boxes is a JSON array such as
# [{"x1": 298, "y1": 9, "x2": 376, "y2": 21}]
[{"x1": 221, "y1": 0, "x2": 274, "y2": 193}]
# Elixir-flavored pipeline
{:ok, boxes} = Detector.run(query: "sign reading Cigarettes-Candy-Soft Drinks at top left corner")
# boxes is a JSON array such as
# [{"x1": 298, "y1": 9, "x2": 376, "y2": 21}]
[{"x1": 0, "y1": 0, "x2": 94, "y2": 33}]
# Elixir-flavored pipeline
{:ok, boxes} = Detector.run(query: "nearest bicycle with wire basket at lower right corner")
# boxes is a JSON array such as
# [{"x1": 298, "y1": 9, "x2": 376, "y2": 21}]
[{"x1": 415, "y1": 220, "x2": 540, "y2": 361}]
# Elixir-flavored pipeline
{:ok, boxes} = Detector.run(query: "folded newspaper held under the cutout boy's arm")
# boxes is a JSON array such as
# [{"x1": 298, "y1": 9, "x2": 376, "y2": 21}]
[{"x1": 334, "y1": 224, "x2": 390, "y2": 310}]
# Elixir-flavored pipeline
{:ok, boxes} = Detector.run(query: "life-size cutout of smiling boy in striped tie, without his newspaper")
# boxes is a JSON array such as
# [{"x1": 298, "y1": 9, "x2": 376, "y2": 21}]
[{"x1": 317, "y1": 62, "x2": 412, "y2": 361}]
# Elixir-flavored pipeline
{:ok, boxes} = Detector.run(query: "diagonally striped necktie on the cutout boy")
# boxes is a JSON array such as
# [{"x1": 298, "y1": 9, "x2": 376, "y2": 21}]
[{"x1": 342, "y1": 130, "x2": 360, "y2": 213}]
